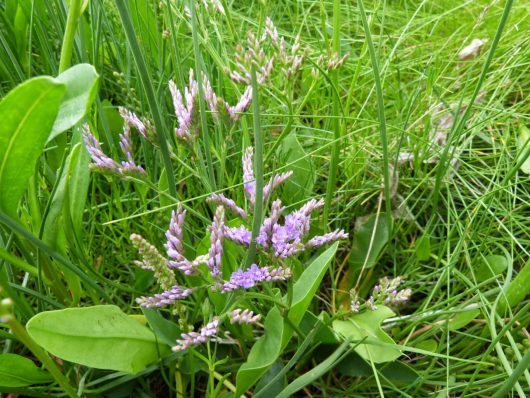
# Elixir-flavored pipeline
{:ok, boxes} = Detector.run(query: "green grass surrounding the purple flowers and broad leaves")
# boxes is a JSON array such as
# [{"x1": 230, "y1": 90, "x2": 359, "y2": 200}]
[{"x1": 0, "y1": 0, "x2": 530, "y2": 397}]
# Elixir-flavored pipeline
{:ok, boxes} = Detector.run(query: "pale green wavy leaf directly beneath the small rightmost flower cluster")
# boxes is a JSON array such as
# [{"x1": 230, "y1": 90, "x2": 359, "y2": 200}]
[{"x1": 333, "y1": 306, "x2": 401, "y2": 363}]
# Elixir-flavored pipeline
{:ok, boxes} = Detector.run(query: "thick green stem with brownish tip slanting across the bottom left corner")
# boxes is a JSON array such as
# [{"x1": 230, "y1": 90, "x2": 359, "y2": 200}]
[{"x1": 0, "y1": 299, "x2": 78, "y2": 397}]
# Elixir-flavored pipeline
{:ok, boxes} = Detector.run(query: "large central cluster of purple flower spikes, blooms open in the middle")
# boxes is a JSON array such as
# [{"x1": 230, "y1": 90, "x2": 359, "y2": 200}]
[{"x1": 131, "y1": 148, "x2": 348, "y2": 351}]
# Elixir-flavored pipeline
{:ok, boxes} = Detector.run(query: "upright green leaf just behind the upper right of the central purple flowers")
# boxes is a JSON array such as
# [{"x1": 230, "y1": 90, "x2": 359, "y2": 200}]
[{"x1": 281, "y1": 133, "x2": 315, "y2": 203}]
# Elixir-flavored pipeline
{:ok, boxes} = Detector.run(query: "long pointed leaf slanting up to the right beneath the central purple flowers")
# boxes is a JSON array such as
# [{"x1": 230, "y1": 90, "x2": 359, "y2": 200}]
[{"x1": 235, "y1": 242, "x2": 338, "y2": 396}]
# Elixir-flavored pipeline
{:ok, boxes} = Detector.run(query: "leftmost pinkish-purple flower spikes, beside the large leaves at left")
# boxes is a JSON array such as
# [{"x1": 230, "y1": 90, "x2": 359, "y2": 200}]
[{"x1": 83, "y1": 108, "x2": 146, "y2": 177}]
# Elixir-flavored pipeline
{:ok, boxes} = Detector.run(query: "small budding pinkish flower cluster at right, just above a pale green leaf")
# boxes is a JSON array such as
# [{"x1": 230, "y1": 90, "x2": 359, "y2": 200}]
[{"x1": 350, "y1": 276, "x2": 412, "y2": 312}]
